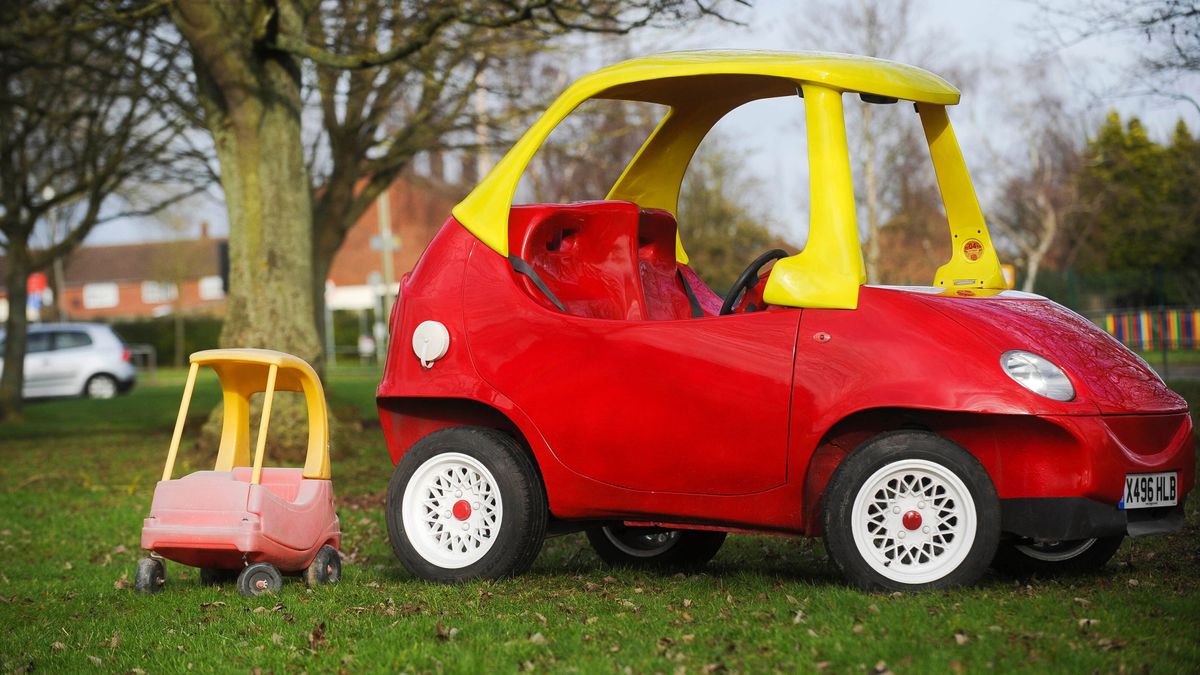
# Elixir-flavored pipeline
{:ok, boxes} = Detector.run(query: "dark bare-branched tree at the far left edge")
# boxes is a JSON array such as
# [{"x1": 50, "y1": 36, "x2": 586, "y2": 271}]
[{"x1": 0, "y1": 1, "x2": 209, "y2": 420}]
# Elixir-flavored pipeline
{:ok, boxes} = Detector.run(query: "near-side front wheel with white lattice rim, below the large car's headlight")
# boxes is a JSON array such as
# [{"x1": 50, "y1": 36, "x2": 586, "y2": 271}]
[{"x1": 822, "y1": 431, "x2": 1000, "y2": 591}]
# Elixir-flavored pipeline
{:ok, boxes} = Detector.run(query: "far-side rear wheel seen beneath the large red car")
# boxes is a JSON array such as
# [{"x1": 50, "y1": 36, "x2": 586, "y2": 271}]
[{"x1": 587, "y1": 525, "x2": 725, "y2": 569}]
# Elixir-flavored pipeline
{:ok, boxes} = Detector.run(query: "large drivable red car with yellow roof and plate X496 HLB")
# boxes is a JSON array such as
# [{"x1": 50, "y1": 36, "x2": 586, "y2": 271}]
[{"x1": 378, "y1": 52, "x2": 1195, "y2": 590}]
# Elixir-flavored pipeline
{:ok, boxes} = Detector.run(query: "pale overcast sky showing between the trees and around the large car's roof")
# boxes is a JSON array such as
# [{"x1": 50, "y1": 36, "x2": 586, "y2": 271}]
[{"x1": 88, "y1": 0, "x2": 1200, "y2": 244}]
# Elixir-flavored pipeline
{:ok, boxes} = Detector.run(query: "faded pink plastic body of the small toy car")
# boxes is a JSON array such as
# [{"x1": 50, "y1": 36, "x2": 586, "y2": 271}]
[{"x1": 142, "y1": 466, "x2": 342, "y2": 572}]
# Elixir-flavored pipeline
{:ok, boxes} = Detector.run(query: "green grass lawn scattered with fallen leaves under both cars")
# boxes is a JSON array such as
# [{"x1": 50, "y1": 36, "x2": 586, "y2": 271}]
[{"x1": 0, "y1": 371, "x2": 1200, "y2": 673}]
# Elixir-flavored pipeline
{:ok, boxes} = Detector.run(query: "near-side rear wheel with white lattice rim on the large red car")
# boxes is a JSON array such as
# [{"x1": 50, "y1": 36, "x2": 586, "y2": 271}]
[{"x1": 386, "y1": 426, "x2": 548, "y2": 583}]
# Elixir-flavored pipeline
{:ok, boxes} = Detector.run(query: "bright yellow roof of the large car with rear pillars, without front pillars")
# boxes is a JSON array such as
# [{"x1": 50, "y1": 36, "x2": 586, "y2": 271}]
[{"x1": 454, "y1": 50, "x2": 959, "y2": 257}]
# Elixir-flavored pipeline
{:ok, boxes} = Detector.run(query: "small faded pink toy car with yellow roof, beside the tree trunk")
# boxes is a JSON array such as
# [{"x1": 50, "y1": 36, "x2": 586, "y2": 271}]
[{"x1": 134, "y1": 350, "x2": 342, "y2": 596}]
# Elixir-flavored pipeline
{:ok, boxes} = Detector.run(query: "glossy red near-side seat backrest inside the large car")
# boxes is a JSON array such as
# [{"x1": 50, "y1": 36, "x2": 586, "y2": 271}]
[{"x1": 509, "y1": 202, "x2": 646, "y2": 319}]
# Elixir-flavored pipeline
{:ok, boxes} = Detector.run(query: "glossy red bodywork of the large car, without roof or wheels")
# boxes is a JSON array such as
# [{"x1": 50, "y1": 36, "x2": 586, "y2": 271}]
[{"x1": 377, "y1": 202, "x2": 1195, "y2": 539}]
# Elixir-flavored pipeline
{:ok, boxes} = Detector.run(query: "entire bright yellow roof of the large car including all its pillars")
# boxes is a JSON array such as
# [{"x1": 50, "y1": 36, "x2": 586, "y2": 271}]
[{"x1": 454, "y1": 52, "x2": 1007, "y2": 309}]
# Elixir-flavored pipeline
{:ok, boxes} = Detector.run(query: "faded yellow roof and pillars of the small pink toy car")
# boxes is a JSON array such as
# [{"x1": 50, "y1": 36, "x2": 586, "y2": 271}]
[{"x1": 162, "y1": 350, "x2": 331, "y2": 483}]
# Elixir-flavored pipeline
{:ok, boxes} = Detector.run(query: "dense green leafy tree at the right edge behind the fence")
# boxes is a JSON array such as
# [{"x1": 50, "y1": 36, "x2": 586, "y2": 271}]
[{"x1": 1075, "y1": 112, "x2": 1200, "y2": 305}]
